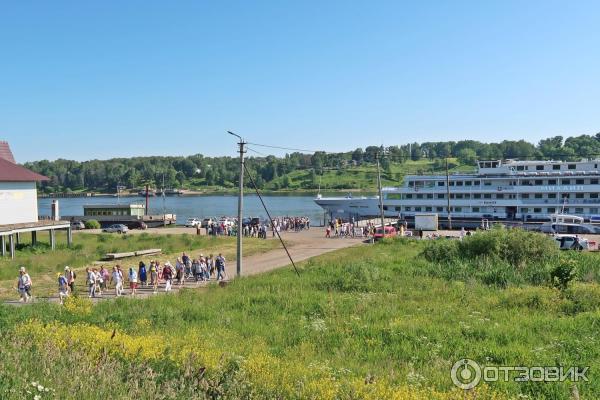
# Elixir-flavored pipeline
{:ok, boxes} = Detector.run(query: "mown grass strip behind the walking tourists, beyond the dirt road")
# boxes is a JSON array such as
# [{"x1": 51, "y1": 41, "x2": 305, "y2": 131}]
[{"x1": 0, "y1": 232, "x2": 278, "y2": 299}]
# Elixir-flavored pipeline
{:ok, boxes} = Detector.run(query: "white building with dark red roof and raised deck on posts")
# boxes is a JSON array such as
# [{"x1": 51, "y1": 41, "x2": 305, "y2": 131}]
[{"x1": 0, "y1": 141, "x2": 71, "y2": 258}]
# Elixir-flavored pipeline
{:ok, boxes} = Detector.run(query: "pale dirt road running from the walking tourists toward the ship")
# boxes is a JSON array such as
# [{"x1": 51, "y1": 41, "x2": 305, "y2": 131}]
[{"x1": 5, "y1": 228, "x2": 364, "y2": 305}]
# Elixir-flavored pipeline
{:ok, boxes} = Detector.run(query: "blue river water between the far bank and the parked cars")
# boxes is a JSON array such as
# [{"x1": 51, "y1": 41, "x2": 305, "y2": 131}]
[{"x1": 38, "y1": 194, "x2": 324, "y2": 225}]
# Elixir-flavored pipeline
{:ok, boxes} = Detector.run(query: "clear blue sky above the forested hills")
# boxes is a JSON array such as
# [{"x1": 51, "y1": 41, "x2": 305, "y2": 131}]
[{"x1": 0, "y1": 0, "x2": 600, "y2": 162}]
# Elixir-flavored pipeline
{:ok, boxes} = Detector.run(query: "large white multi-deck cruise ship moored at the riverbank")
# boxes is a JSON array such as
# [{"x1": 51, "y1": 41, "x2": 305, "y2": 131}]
[{"x1": 315, "y1": 160, "x2": 600, "y2": 226}]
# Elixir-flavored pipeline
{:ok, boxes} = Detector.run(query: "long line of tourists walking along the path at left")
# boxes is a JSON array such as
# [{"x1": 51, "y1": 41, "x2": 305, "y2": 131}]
[{"x1": 17, "y1": 253, "x2": 227, "y2": 304}]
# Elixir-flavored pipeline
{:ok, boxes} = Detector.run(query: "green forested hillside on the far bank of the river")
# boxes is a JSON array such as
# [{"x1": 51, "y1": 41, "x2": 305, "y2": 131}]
[{"x1": 25, "y1": 133, "x2": 600, "y2": 193}]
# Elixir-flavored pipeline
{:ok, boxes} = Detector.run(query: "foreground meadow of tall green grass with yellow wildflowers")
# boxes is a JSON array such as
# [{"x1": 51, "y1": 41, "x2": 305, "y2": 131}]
[{"x1": 0, "y1": 233, "x2": 600, "y2": 400}]
